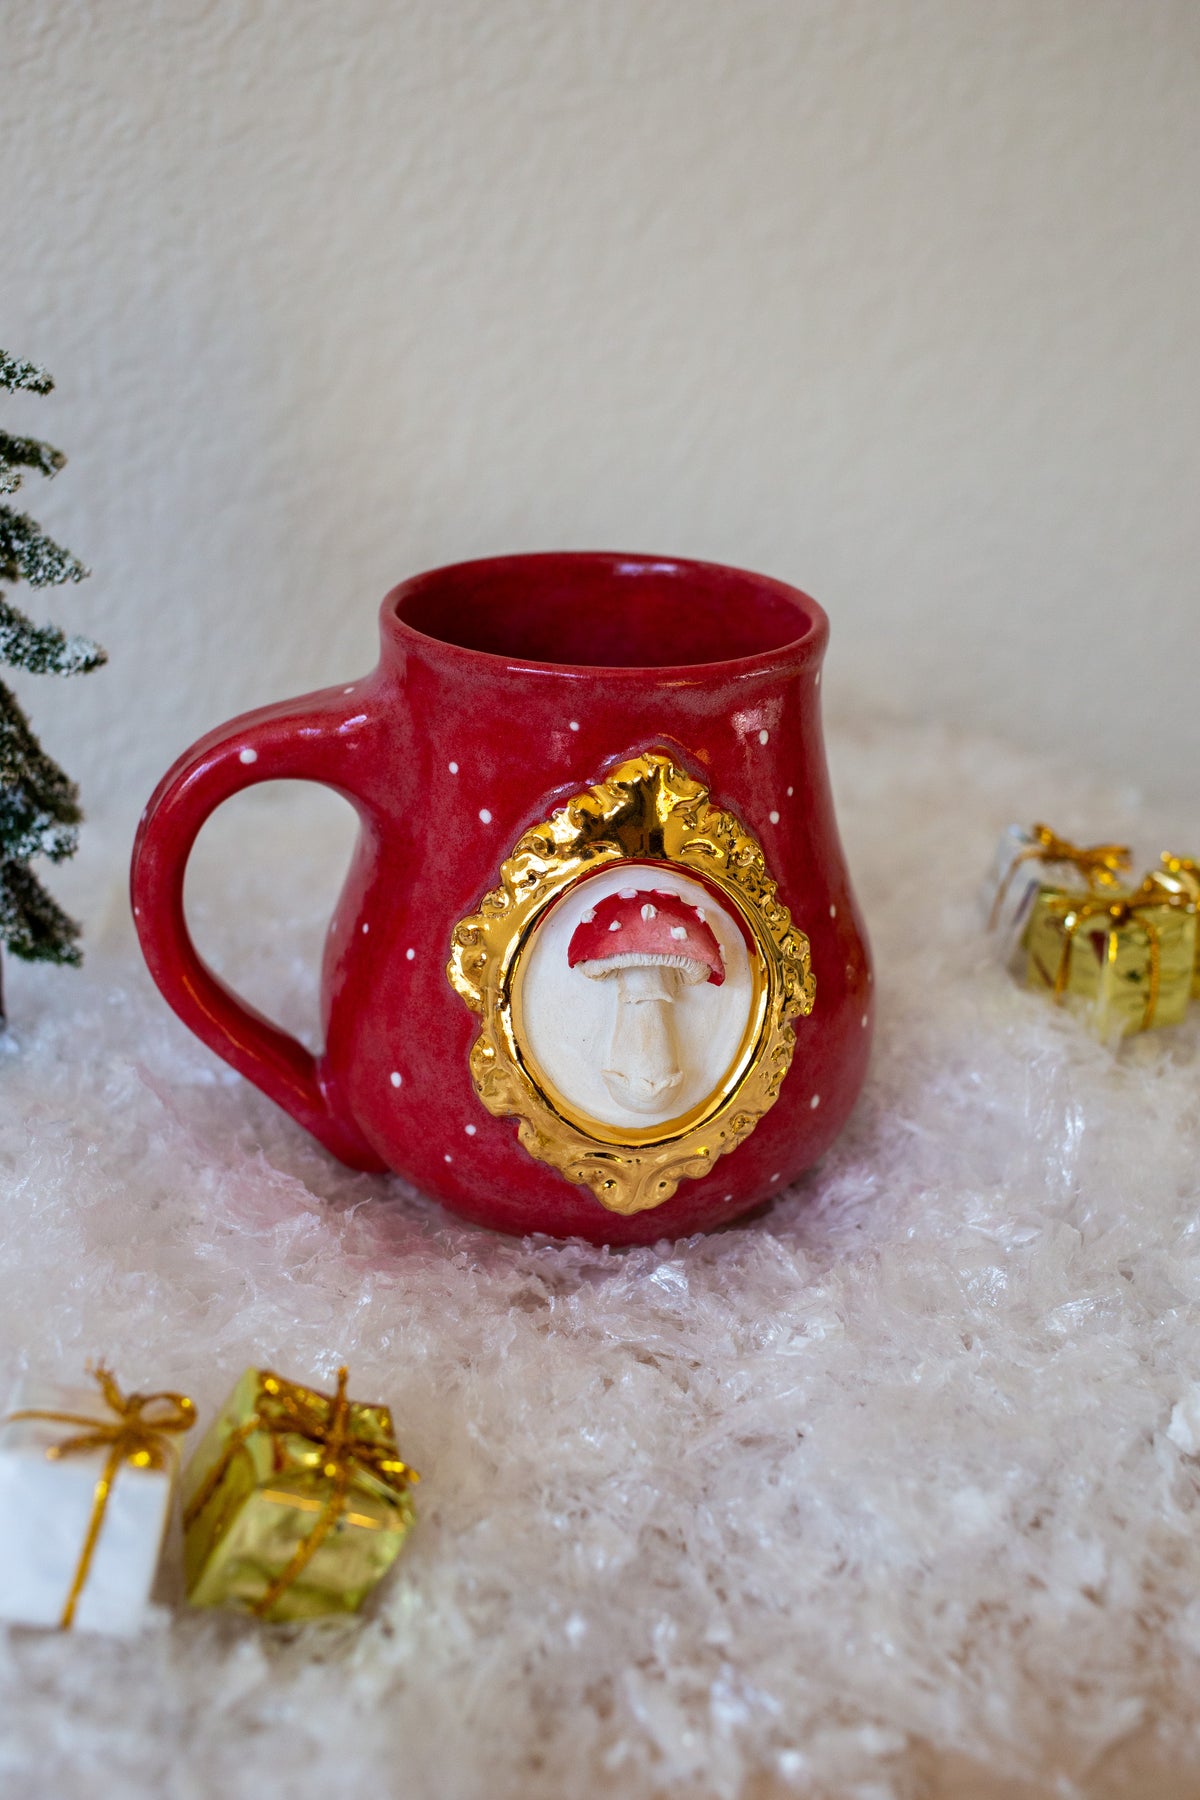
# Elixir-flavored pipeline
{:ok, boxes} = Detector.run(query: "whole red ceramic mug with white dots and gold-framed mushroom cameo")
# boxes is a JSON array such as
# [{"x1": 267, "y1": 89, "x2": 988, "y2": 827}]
[{"x1": 133, "y1": 554, "x2": 871, "y2": 1244}]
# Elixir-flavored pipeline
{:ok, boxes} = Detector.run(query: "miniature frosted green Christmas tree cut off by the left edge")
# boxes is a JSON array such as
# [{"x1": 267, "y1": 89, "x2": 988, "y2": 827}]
[{"x1": 0, "y1": 351, "x2": 104, "y2": 1021}]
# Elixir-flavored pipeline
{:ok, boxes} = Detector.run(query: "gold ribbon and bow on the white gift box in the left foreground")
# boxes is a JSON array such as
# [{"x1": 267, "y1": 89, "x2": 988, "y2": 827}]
[{"x1": 0, "y1": 1363, "x2": 196, "y2": 1631}]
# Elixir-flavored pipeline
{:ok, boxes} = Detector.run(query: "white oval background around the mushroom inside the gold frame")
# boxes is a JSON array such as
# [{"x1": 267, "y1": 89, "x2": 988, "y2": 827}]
[{"x1": 520, "y1": 862, "x2": 754, "y2": 1130}]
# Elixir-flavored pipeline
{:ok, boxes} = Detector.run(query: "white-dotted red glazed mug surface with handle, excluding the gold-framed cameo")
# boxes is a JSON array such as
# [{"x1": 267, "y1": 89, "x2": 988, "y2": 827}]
[{"x1": 133, "y1": 554, "x2": 871, "y2": 1244}]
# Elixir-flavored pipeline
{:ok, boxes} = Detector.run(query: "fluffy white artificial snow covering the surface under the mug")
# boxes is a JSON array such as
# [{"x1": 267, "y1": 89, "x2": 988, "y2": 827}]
[{"x1": 0, "y1": 727, "x2": 1200, "y2": 1800}]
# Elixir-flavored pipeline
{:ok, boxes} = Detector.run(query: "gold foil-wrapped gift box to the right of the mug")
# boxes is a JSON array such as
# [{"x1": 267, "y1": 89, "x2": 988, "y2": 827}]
[{"x1": 1025, "y1": 875, "x2": 1196, "y2": 1039}]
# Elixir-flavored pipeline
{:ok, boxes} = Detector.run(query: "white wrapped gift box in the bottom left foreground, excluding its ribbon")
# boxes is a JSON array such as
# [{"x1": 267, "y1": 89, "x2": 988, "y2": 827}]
[{"x1": 0, "y1": 1382, "x2": 178, "y2": 1636}]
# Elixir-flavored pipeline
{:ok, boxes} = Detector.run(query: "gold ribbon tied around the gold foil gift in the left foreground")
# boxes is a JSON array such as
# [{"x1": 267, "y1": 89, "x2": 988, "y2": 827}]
[{"x1": 184, "y1": 1368, "x2": 421, "y2": 1618}]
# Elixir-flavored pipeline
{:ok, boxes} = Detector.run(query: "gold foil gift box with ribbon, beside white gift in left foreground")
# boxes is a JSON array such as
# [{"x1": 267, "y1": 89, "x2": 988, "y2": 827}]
[{"x1": 182, "y1": 1368, "x2": 419, "y2": 1620}]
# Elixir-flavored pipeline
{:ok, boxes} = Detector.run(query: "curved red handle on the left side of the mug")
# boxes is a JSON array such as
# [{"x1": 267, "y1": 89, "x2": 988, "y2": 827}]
[{"x1": 130, "y1": 688, "x2": 387, "y2": 1172}]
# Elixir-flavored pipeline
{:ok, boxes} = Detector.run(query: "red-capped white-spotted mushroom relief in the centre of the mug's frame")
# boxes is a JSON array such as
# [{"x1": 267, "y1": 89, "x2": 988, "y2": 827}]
[{"x1": 567, "y1": 887, "x2": 725, "y2": 1112}]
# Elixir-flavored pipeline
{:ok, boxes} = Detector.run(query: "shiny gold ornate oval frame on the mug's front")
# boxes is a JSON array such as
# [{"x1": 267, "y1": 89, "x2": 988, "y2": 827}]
[{"x1": 446, "y1": 751, "x2": 815, "y2": 1215}]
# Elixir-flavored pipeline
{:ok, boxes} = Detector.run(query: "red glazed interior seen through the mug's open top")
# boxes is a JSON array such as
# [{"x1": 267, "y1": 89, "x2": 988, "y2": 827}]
[{"x1": 394, "y1": 553, "x2": 824, "y2": 668}]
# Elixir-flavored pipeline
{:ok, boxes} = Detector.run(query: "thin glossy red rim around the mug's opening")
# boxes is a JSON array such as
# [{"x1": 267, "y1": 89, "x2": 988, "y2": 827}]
[{"x1": 380, "y1": 551, "x2": 829, "y2": 682}]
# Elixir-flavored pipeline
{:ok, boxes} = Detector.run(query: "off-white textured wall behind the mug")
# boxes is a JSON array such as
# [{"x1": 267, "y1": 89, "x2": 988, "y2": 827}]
[{"x1": 0, "y1": 0, "x2": 1200, "y2": 824}]
